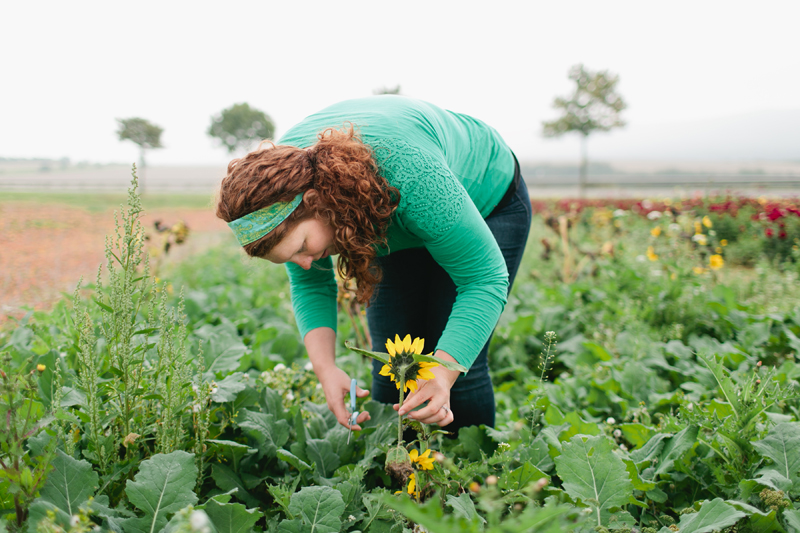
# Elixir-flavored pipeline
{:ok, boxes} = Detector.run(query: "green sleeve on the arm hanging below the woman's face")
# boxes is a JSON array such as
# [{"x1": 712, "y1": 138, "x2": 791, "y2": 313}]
[{"x1": 286, "y1": 257, "x2": 337, "y2": 338}]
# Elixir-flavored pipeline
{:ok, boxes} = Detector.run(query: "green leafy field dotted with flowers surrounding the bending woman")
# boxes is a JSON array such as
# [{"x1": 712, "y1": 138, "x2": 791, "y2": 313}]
[{"x1": 0, "y1": 179, "x2": 800, "y2": 533}]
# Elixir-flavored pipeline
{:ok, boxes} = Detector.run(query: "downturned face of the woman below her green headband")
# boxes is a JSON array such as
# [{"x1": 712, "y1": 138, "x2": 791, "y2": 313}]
[{"x1": 265, "y1": 217, "x2": 336, "y2": 270}]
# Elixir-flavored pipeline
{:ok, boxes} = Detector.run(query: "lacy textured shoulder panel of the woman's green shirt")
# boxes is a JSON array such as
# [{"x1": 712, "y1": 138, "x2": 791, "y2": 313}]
[{"x1": 368, "y1": 139, "x2": 469, "y2": 241}]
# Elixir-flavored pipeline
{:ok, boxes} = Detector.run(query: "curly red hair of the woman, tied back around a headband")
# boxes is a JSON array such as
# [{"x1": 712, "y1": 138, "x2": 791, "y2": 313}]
[{"x1": 217, "y1": 124, "x2": 400, "y2": 303}]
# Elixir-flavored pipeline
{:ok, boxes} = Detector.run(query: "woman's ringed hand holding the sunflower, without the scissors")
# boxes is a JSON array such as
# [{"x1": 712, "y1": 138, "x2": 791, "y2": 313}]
[{"x1": 394, "y1": 350, "x2": 460, "y2": 426}]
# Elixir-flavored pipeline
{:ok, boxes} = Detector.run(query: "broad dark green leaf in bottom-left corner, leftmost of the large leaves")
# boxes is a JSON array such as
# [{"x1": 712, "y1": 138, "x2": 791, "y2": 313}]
[{"x1": 28, "y1": 450, "x2": 98, "y2": 532}]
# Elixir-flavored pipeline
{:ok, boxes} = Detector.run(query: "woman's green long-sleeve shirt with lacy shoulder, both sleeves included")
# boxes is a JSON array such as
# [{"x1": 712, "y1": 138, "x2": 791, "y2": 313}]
[{"x1": 279, "y1": 96, "x2": 514, "y2": 368}]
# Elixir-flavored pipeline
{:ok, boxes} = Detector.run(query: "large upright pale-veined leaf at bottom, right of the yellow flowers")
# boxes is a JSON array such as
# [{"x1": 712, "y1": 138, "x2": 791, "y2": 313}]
[{"x1": 555, "y1": 435, "x2": 633, "y2": 526}]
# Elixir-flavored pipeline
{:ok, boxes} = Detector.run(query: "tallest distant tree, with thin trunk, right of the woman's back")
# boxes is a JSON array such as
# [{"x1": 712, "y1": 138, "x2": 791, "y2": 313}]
[{"x1": 542, "y1": 64, "x2": 628, "y2": 196}]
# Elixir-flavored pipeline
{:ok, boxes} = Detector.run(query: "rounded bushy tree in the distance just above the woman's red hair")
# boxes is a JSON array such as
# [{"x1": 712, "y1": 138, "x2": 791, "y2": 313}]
[{"x1": 206, "y1": 103, "x2": 275, "y2": 153}]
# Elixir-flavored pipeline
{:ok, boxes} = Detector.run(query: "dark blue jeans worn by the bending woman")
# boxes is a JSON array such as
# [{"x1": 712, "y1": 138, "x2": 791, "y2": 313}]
[{"x1": 367, "y1": 172, "x2": 531, "y2": 433}]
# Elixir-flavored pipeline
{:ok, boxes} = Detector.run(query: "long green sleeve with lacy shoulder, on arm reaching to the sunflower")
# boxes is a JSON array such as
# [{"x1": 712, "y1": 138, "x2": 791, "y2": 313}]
[{"x1": 376, "y1": 139, "x2": 508, "y2": 368}]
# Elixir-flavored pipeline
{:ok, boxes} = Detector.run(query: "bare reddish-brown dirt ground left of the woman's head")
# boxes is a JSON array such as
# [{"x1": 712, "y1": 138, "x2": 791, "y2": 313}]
[{"x1": 0, "y1": 202, "x2": 229, "y2": 325}]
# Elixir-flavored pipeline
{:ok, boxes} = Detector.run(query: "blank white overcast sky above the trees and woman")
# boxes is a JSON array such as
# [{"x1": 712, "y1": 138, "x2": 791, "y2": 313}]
[{"x1": 0, "y1": 0, "x2": 800, "y2": 165}]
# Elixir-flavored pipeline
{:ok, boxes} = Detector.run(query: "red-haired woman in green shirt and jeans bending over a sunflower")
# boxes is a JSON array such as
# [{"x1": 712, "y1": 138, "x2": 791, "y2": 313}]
[{"x1": 217, "y1": 96, "x2": 531, "y2": 431}]
